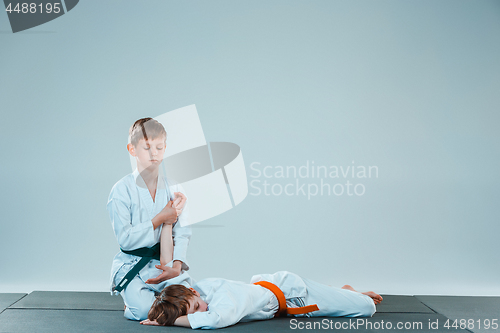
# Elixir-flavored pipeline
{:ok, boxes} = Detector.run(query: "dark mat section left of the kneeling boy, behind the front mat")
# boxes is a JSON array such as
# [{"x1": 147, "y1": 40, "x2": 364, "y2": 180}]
[{"x1": 10, "y1": 291, "x2": 123, "y2": 311}]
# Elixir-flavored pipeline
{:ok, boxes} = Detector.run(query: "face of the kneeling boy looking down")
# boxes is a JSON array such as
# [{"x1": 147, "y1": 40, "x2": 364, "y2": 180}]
[{"x1": 127, "y1": 137, "x2": 166, "y2": 170}]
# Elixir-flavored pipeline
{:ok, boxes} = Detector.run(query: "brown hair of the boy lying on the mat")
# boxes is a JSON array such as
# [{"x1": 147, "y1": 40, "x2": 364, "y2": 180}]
[{"x1": 148, "y1": 284, "x2": 195, "y2": 326}]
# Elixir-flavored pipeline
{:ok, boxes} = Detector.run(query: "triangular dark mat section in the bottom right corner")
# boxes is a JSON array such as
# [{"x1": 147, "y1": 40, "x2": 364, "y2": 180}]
[{"x1": 416, "y1": 296, "x2": 500, "y2": 333}]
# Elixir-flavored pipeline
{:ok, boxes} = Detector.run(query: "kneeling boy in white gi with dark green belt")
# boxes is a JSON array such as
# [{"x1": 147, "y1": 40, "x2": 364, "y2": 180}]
[{"x1": 107, "y1": 118, "x2": 192, "y2": 320}]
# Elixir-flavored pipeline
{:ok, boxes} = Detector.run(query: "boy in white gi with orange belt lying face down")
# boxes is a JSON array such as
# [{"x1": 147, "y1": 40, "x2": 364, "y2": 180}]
[{"x1": 141, "y1": 271, "x2": 382, "y2": 329}]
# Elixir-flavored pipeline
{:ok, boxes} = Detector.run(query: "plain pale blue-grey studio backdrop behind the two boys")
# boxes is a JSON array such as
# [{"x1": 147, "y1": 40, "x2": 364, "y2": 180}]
[{"x1": 0, "y1": 0, "x2": 500, "y2": 295}]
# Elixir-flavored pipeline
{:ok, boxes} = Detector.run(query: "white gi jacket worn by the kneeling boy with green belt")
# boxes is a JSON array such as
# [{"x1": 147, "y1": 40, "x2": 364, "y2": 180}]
[{"x1": 107, "y1": 169, "x2": 191, "y2": 290}]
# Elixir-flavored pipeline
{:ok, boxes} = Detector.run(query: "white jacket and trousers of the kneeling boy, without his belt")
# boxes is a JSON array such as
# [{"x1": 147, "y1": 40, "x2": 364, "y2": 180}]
[{"x1": 107, "y1": 169, "x2": 192, "y2": 320}]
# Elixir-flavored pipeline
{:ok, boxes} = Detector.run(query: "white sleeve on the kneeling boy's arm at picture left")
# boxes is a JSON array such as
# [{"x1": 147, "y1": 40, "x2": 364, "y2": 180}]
[{"x1": 107, "y1": 183, "x2": 155, "y2": 250}]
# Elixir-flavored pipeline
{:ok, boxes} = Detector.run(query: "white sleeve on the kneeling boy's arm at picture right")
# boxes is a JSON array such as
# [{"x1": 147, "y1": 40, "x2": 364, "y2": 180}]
[{"x1": 172, "y1": 185, "x2": 192, "y2": 271}]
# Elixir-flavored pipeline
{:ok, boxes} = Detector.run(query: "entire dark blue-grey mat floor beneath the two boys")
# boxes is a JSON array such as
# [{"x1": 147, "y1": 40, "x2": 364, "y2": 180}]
[{"x1": 0, "y1": 291, "x2": 488, "y2": 333}]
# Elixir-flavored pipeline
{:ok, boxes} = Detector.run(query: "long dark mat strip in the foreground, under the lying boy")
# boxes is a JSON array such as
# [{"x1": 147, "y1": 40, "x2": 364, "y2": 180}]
[{"x1": 0, "y1": 309, "x2": 465, "y2": 333}]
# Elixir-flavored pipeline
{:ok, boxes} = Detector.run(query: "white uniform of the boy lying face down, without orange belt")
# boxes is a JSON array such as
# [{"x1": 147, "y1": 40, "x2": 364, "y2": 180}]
[{"x1": 187, "y1": 271, "x2": 375, "y2": 329}]
